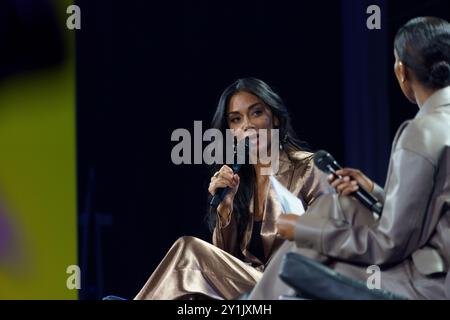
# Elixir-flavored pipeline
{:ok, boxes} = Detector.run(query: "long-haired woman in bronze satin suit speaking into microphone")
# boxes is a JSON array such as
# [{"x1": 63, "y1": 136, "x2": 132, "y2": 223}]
[{"x1": 135, "y1": 78, "x2": 329, "y2": 299}]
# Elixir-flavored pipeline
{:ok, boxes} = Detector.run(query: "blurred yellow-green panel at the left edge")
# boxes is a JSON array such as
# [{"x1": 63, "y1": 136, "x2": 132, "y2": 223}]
[{"x1": 0, "y1": 0, "x2": 77, "y2": 299}]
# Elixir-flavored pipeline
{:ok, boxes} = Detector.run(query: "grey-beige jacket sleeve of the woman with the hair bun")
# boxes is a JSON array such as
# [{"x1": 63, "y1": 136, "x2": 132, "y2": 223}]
[{"x1": 295, "y1": 122, "x2": 436, "y2": 264}]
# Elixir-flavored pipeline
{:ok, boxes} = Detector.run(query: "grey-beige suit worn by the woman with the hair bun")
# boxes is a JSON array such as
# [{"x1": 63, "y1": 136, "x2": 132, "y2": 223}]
[{"x1": 250, "y1": 87, "x2": 450, "y2": 299}]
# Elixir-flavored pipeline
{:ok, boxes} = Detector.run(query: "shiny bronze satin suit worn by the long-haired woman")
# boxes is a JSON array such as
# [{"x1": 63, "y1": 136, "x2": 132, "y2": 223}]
[{"x1": 135, "y1": 151, "x2": 330, "y2": 299}]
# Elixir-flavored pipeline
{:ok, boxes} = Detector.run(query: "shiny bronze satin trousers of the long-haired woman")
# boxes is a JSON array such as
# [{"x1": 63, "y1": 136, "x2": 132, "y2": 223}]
[{"x1": 135, "y1": 236, "x2": 262, "y2": 300}]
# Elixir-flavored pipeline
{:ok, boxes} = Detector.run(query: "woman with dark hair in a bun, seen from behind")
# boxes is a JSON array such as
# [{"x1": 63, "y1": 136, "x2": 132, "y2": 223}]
[{"x1": 249, "y1": 17, "x2": 450, "y2": 299}]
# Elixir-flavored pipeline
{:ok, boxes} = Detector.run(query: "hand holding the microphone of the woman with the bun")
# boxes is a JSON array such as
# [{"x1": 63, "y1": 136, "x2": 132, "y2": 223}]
[{"x1": 328, "y1": 168, "x2": 374, "y2": 196}]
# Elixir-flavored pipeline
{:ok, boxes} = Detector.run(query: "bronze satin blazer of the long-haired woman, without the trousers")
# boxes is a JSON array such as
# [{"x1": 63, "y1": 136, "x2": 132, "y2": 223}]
[{"x1": 212, "y1": 151, "x2": 331, "y2": 270}]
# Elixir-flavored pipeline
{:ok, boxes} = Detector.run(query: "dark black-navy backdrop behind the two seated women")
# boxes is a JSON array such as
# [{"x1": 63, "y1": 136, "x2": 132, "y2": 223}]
[{"x1": 76, "y1": 0, "x2": 450, "y2": 299}]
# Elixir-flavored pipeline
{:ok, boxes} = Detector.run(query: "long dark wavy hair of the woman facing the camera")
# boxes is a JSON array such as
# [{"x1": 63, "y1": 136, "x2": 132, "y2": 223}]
[{"x1": 207, "y1": 78, "x2": 309, "y2": 241}]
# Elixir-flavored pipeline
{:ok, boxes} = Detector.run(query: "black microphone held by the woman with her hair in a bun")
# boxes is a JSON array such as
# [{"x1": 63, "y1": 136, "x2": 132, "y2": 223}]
[{"x1": 314, "y1": 150, "x2": 383, "y2": 215}]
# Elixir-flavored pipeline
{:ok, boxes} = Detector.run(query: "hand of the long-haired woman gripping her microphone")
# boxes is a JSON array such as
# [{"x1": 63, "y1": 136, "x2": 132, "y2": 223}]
[{"x1": 208, "y1": 165, "x2": 240, "y2": 216}]
